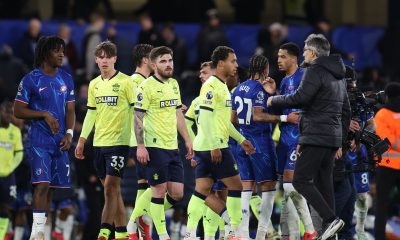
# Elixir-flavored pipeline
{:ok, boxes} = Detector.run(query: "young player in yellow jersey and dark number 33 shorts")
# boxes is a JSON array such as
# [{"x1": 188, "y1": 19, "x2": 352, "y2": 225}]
[{"x1": 75, "y1": 41, "x2": 135, "y2": 240}]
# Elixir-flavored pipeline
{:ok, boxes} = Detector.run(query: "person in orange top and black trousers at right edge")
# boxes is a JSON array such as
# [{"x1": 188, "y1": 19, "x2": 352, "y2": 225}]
[{"x1": 375, "y1": 82, "x2": 400, "y2": 239}]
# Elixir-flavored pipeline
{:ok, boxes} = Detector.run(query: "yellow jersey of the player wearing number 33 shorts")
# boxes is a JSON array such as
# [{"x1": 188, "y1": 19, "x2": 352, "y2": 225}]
[{"x1": 87, "y1": 71, "x2": 136, "y2": 147}]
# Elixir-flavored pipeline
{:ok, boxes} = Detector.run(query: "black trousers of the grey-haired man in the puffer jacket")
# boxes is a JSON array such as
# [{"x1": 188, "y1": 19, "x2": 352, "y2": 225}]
[{"x1": 293, "y1": 145, "x2": 337, "y2": 223}]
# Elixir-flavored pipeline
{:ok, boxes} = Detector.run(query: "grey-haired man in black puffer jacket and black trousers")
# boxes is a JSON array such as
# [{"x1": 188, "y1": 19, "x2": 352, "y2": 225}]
[{"x1": 267, "y1": 34, "x2": 350, "y2": 240}]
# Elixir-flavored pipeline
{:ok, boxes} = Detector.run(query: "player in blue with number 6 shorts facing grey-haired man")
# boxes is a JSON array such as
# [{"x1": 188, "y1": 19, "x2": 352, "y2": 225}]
[{"x1": 277, "y1": 43, "x2": 317, "y2": 240}]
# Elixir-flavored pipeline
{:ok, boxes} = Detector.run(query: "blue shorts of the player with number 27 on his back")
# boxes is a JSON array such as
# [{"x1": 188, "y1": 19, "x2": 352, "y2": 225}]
[{"x1": 236, "y1": 137, "x2": 278, "y2": 183}]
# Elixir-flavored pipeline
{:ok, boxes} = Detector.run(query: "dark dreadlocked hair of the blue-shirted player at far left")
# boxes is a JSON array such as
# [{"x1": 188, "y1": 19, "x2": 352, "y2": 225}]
[{"x1": 33, "y1": 36, "x2": 65, "y2": 68}]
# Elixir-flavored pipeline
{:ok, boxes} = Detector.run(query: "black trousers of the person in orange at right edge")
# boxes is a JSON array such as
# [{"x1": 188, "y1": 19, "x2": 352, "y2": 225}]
[{"x1": 375, "y1": 167, "x2": 400, "y2": 239}]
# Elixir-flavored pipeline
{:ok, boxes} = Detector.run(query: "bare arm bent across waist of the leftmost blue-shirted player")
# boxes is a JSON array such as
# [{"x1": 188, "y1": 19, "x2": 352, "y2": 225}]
[{"x1": 14, "y1": 100, "x2": 60, "y2": 134}]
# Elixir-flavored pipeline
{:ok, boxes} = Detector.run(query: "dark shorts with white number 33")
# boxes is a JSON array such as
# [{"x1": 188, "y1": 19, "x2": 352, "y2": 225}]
[{"x1": 93, "y1": 146, "x2": 129, "y2": 179}]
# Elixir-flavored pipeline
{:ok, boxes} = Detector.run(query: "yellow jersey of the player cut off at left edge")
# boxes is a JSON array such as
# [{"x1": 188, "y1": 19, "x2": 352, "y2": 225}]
[{"x1": 0, "y1": 124, "x2": 23, "y2": 177}]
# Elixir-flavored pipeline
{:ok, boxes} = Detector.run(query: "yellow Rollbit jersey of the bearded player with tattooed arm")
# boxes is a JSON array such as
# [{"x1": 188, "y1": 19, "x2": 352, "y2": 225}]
[{"x1": 135, "y1": 76, "x2": 182, "y2": 150}]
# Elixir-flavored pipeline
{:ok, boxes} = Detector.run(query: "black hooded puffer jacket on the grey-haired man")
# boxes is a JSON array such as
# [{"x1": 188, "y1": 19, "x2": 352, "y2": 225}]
[{"x1": 272, "y1": 55, "x2": 351, "y2": 147}]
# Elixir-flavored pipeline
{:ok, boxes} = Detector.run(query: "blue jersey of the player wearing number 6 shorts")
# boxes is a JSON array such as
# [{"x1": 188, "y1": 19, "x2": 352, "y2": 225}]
[{"x1": 280, "y1": 68, "x2": 304, "y2": 145}]
